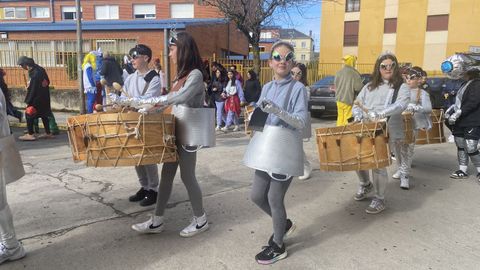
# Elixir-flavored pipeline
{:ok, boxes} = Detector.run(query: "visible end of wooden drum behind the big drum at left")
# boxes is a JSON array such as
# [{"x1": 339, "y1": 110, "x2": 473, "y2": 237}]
[{"x1": 67, "y1": 114, "x2": 87, "y2": 162}]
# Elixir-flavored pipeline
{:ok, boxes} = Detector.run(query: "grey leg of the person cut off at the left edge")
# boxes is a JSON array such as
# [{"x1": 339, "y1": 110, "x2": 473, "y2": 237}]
[{"x1": 0, "y1": 170, "x2": 18, "y2": 248}]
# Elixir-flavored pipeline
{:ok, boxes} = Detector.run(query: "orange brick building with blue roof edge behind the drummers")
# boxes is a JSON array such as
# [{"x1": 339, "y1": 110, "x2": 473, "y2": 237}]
[{"x1": 0, "y1": 0, "x2": 248, "y2": 87}]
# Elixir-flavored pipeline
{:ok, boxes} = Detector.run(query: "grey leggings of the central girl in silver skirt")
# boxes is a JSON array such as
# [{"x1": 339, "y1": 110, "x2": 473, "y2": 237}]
[{"x1": 251, "y1": 170, "x2": 293, "y2": 246}]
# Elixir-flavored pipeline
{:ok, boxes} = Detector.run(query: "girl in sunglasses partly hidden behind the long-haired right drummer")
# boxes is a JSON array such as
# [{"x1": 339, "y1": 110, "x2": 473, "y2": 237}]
[{"x1": 392, "y1": 67, "x2": 432, "y2": 190}]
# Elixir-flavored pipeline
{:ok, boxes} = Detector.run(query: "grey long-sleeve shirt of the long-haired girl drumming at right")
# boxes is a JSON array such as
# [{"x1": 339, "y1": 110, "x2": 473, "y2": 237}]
[{"x1": 353, "y1": 83, "x2": 410, "y2": 140}]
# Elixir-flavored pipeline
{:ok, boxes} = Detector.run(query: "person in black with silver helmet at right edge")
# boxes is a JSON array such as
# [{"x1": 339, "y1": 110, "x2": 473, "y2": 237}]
[{"x1": 441, "y1": 54, "x2": 480, "y2": 183}]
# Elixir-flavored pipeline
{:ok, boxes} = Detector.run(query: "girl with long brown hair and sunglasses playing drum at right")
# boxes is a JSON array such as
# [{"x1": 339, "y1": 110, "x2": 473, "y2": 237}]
[{"x1": 352, "y1": 53, "x2": 410, "y2": 214}]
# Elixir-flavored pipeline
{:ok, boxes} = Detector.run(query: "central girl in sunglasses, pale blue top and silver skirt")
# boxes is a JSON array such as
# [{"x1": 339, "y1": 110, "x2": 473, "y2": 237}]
[{"x1": 244, "y1": 41, "x2": 308, "y2": 264}]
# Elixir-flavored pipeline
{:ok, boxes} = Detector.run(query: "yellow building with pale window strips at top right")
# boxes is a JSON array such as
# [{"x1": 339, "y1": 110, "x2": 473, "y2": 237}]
[{"x1": 319, "y1": 0, "x2": 480, "y2": 72}]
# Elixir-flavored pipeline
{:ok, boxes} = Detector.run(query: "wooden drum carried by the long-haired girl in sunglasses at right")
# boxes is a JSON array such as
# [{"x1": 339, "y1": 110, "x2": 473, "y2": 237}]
[{"x1": 315, "y1": 122, "x2": 391, "y2": 171}]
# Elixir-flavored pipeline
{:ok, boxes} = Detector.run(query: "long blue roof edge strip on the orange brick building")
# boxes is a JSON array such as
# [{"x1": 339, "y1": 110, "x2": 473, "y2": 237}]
[{"x1": 0, "y1": 18, "x2": 227, "y2": 32}]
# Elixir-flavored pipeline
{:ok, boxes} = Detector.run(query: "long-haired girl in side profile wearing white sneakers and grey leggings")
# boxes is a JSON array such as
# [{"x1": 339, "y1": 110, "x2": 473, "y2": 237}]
[{"x1": 128, "y1": 32, "x2": 209, "y2": 237}]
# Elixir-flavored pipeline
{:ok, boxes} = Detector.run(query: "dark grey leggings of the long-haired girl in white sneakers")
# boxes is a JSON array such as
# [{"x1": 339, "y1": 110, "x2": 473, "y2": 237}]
[{"x1": 155, "y1": 145, "x2": 204, "y2": 217}]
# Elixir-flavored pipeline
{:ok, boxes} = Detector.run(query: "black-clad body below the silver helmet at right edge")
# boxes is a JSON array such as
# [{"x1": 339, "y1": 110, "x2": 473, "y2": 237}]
[{"x1": 445, "y1": 67, "x2": 480, "y2": 182}]
